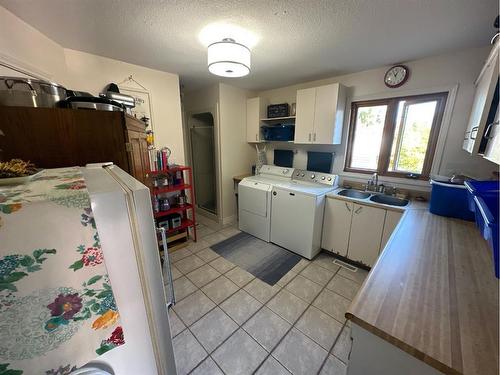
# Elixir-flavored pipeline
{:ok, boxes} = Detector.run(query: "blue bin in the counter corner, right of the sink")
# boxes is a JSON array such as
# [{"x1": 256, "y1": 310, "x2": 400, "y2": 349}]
[{"x1": 429, "y1": 180, "x2": 474, "y2": 221}]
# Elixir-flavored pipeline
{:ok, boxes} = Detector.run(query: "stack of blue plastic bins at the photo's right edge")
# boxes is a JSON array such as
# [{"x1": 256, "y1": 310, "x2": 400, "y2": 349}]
[{"x1": 465, "y1": 181, "x2": 500, "y2": 278}]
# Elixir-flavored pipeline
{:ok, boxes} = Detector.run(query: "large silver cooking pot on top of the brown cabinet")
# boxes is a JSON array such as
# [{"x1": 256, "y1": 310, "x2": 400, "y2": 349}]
[{"x1": 0, "y1": 77, "x2": 66, "y2": 108}]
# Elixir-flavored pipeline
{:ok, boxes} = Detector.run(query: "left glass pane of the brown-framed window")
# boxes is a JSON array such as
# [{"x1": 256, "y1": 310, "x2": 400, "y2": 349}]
[{"x1": 350, "y1": 105, "x2": 387, "y2": 170}]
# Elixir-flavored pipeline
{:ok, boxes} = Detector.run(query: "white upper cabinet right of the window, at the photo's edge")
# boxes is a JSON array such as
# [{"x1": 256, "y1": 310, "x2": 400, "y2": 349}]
[{"x1": 462, "y1": 42, "x2": 499, "y2": 154}]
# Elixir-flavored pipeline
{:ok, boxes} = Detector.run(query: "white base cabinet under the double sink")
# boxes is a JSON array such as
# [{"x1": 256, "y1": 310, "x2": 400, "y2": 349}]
[{"x1": 321, "y1": 197, "x2": 403, "y2": 267}]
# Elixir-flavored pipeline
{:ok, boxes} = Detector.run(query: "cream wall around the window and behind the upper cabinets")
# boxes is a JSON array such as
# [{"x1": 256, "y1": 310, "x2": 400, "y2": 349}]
[{"x1": 257, "y1": 47, "x2": 497, "y2": 188}]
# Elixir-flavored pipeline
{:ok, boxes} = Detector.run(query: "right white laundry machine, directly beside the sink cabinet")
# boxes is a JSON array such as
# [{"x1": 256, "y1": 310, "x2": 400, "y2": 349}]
[{"x1": 271, "y1": 169, "x2": 338, "y2": 259}]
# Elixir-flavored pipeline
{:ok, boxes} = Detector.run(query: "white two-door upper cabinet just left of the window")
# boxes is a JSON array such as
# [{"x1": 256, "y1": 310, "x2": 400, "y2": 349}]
[{"x1": 295, "y1": 83, "x2": 346, "y2": 145}]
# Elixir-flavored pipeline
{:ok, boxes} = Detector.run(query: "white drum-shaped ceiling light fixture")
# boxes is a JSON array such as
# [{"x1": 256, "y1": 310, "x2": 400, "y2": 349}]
[{"x1": 208, "y1": 38, "x2": 250, "y2": 77}]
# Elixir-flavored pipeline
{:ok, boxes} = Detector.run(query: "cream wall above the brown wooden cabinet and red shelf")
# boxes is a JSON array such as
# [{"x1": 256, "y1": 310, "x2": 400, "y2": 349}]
[{"x1": 0, "y1": 6, "x2": 184, "y2": 164}]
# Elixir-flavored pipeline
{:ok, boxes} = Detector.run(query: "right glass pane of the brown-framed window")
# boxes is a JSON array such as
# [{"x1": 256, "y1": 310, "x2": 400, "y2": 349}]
[{"x1": 389, "y1": 101, "x2": 437, "y2": 173}]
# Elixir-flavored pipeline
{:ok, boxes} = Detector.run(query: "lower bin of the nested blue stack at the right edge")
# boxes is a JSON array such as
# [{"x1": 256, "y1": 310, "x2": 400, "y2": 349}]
[{"x1": 474, "y1": 192, "x2": 500, "y2": 278}]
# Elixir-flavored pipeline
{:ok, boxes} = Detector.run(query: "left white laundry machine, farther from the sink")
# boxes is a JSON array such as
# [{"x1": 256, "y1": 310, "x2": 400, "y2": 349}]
[{"x1": 238, "y1": 165, "x2": 294, "y2": 242}]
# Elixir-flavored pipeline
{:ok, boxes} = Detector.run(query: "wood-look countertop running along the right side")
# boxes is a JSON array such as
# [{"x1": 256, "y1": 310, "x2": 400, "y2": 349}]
[{"x1": 346, "y1": 209, "x2": 499, "y2": 375}]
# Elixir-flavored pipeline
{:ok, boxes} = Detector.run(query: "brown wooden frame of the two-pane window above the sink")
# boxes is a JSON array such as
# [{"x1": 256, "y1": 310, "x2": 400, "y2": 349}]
[{"x1": 344, "y1": 92, "x2": 448, "y2": 180}]
